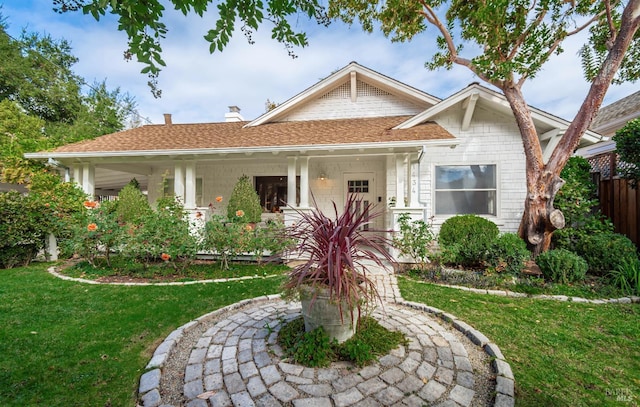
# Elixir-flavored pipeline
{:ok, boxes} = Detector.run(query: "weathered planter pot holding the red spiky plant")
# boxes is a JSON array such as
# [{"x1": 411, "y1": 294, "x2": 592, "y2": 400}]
[{"x1": 300, "y1": 288, "x2": 358, "y2": 343}]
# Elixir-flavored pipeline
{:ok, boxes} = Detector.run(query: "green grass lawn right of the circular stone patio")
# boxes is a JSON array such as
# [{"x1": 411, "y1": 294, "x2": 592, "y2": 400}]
[{"x1": 399, "y1": 278, "x2": 640, "y2": 406}]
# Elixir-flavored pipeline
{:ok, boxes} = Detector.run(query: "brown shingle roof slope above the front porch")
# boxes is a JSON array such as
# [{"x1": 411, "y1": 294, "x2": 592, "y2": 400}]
[{"x1": 54, "y1": 116, "x2": 454, "y2": 153}]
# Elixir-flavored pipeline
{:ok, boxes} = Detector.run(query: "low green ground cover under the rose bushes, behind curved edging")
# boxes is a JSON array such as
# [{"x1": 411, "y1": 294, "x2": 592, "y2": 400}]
[{"x1": 63, "y1": 256, "x2": 289, "y2": 281}]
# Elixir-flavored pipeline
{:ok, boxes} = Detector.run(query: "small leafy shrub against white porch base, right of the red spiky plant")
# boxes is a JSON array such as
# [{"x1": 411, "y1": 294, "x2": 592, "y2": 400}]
[{"x1": 393, "y1": 213, "x2": 434, "y2": 270}]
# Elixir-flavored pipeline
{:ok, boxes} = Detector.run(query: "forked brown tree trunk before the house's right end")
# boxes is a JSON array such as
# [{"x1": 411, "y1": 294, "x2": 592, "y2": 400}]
[{"x1": 502, "y1": 0, "x2": 640, "y2": 256}]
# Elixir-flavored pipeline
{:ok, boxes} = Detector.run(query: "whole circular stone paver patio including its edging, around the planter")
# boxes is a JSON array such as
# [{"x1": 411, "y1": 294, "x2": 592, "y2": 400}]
[{"x1": 139, "y1": 267, "x2": 514, "y2": 407}]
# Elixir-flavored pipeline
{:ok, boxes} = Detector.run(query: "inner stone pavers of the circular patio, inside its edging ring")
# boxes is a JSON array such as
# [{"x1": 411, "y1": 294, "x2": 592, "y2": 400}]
[{"x1": 178, "y1": 301, "x2": 482, "y2": 407}]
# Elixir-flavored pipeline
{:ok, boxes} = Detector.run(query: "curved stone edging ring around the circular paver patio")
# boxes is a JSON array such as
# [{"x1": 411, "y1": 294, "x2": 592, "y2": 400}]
[{"x1": 138, "y1": 294, "x2": 515, "y2": 407}]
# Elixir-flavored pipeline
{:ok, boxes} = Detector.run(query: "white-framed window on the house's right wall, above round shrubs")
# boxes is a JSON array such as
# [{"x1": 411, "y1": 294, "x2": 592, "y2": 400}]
[{"x1": 435, "y1": 165, "x2": 497, "y2": 216}]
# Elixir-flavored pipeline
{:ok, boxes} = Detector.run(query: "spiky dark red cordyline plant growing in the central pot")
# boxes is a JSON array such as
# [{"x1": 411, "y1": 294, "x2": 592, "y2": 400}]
[{"x1": 284, "y1": 194, "x2": 395, "y2": 322}]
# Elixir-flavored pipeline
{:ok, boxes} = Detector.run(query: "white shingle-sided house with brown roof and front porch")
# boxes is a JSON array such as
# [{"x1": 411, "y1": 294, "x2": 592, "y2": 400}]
[{"x1": 26, "y1": 62, "x2": 600, "y2": 236}]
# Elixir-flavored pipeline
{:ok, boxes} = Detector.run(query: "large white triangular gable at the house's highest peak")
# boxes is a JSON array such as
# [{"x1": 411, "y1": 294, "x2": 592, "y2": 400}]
[{"x1": 246, "y1": 62, "x2": 440, "y2": 127}]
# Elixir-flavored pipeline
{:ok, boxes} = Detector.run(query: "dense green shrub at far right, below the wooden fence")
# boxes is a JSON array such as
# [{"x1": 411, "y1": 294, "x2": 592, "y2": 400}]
[{"x1": 578, "y1": 233, "x2": 637, "y2": 276}]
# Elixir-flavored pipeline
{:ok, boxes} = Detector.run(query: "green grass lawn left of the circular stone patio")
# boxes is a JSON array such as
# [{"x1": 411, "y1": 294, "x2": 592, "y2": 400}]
[{"x1": 0, "y1": 264, "x2": 282, "y2": 407}]
